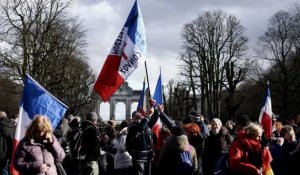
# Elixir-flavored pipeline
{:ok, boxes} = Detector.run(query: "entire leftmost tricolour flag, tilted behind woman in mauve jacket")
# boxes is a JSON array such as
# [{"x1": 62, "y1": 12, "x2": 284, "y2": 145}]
[{"x1": 11, "y1": 75, "x2": 68, "y2": 175}]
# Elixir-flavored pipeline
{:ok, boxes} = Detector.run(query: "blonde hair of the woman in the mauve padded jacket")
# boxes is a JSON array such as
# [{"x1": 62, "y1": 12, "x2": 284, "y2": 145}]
[{"x1": 25, "y1": 115, "x2": 52, "y2": 138}]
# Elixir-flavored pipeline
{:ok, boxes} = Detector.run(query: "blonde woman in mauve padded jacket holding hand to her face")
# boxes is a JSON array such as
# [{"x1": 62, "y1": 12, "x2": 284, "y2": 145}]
[{"x1": 14, "y1": 115, "x2": 65, "y2": 175}]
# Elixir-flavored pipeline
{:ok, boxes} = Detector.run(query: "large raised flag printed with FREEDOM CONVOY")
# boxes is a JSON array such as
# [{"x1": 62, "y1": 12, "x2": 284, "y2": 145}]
[{"x1": 94, "y1": 0, "x2": 147, "y2": 102}]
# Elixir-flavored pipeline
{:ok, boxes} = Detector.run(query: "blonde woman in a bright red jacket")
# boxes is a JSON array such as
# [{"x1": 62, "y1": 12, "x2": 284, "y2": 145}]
[{"x1": 229, "y1": 123, "x2": 272, "y2": 175}]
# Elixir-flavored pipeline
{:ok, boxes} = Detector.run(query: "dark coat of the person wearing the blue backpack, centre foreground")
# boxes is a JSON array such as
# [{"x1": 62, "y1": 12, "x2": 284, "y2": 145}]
[{"x1": 156, "y1": 135, "x2": 198, "y2": 175}]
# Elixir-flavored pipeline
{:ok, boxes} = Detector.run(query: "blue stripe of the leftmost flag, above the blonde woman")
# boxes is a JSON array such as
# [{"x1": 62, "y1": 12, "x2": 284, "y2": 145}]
[{"x1": 21, "y1": 75, "x2": 68, "y2": 128}]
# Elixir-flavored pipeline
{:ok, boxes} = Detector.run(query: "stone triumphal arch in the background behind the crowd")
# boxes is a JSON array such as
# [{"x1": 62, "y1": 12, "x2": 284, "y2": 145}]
[{"x1": 99, "y1": 82, "x2": 141, "y2": 119}]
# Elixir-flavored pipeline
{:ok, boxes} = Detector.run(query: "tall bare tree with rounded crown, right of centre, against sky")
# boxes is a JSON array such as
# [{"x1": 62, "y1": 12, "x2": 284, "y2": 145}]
[{"x1": 181, "y1": 10, "x2": 248, "y2": 117}]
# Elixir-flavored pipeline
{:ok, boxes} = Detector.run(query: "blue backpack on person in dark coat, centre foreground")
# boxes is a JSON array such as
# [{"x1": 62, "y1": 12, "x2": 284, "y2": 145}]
[{"x1": 176, "y1": 145, "x2": 194, "y2": 175}]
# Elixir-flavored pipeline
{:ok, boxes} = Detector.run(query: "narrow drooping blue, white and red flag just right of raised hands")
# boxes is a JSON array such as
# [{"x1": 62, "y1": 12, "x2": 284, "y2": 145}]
[{"x1": 152, "y1": 72, "x2": 164, "y2": 144}]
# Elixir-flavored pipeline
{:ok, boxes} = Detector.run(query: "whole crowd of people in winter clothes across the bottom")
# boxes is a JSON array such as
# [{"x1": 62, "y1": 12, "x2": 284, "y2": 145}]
[{"x1": 0, "y1": 100, "x2": 300, "y2": 175}]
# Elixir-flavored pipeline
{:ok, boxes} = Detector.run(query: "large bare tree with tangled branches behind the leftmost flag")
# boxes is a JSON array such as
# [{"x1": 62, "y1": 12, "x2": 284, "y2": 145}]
[{"x1": 0, "y1": 0, "x2": 94, "y2": 114}]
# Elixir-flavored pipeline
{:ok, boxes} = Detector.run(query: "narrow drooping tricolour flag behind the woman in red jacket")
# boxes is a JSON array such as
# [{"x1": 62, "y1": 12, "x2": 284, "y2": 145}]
[{"x1": 259, "y1": 83, "x2": 273, "y2": 139}]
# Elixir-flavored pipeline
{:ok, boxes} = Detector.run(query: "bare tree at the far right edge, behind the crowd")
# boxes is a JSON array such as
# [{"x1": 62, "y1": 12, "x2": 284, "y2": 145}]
[{"x1": 258, "y1": 6, "x2": 300, "y2": 117}]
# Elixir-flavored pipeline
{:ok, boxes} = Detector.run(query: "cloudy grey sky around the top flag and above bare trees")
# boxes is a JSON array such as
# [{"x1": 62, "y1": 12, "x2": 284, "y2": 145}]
[{"x1": 72, "y1": 0, "x2": 299, "y2": 93}]
